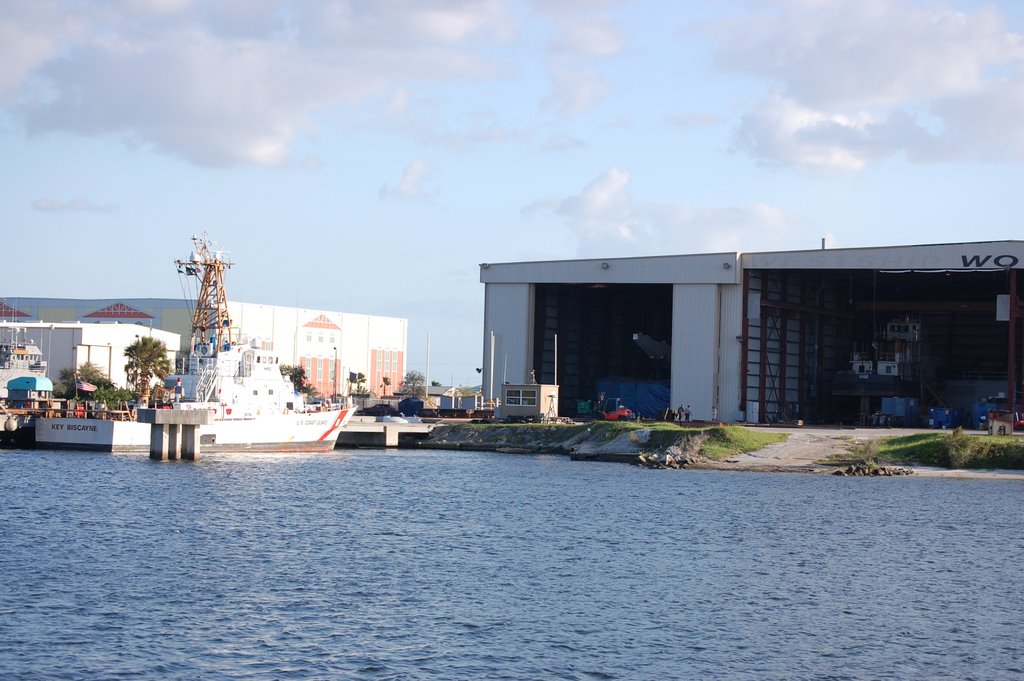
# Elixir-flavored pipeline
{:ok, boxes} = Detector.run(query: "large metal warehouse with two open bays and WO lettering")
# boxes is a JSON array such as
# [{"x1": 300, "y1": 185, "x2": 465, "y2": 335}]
[{"x1": 480, "y1": 236, "x2": 1024, "y2": 425}]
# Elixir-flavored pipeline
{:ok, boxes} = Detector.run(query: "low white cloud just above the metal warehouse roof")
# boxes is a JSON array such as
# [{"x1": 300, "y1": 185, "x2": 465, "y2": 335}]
[{"x1": 536, "y1": 169, "x2": 819, "y2": 257}]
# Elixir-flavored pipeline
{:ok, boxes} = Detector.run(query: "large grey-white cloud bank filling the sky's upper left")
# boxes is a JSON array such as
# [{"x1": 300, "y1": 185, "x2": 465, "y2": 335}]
[{"x1": 0, "y1": 0, "x2": 511, "y2": 166}]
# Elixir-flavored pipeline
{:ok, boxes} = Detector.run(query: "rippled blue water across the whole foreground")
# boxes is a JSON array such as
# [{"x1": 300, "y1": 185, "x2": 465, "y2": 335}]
[{"x1": 0, "y1": 450, "x2": 1024, "y2": 679}]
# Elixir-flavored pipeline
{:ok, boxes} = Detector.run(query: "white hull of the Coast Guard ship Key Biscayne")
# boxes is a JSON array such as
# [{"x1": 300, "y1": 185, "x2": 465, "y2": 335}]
[{"x1": 36, "y1": 409, "x2": 354, "y2": 453}]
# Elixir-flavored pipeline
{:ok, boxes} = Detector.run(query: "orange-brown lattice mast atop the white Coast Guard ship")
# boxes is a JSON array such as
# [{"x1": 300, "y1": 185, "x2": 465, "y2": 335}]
[{"x1": 175, "y1": 232, "x2": 238, "y2": 353}]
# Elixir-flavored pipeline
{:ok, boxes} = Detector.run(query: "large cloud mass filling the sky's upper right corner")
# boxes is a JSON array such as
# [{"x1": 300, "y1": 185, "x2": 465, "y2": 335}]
[{"x1": 712, "y1": 0, "x2": 1024, "y2": 171}]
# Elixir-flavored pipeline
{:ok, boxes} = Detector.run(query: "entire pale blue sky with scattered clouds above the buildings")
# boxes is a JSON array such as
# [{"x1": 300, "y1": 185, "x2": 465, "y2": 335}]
[{"x1": 0, "y1": 0, "x2": 1024, "y2": 385}]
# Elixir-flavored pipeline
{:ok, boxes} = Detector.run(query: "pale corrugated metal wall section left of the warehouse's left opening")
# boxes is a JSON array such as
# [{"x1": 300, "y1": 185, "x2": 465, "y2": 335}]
[{"x1": 482, "y1": 284, "x2": 534, "y2": 399}]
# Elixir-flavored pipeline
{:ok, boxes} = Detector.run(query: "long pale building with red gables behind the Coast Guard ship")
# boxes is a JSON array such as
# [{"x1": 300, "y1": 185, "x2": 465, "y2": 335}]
[{"x1": 0, "y1": 298, "x2": 409, "y2": 395}]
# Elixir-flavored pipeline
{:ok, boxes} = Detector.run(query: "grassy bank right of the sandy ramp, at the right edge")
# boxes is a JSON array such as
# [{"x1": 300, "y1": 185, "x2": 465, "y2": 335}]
[{"x1": 843, "y1": 428, "x2": 1024, "y2": 470}]
